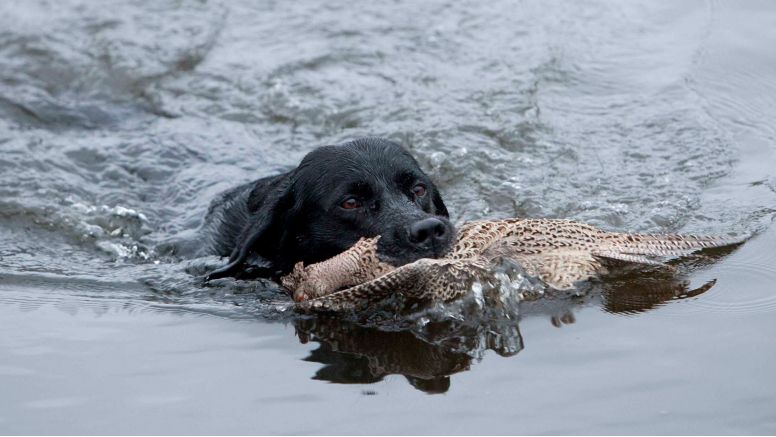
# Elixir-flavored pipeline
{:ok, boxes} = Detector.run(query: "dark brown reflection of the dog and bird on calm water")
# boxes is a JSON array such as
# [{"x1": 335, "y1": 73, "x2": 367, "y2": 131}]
[{"x1": 296, "y1": 258, "x2": 714, "y2": 393}]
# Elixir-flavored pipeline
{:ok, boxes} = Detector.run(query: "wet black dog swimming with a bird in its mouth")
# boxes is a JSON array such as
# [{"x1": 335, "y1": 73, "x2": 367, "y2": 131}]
[{"x1": 205, "y1": 138, "x2": 454, "y2": 279}]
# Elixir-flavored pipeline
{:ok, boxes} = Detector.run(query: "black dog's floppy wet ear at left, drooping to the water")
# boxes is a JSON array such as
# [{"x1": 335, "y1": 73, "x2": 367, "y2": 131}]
[{"x1": 205, "y1": 171, "x2": 294, "y2": 281}]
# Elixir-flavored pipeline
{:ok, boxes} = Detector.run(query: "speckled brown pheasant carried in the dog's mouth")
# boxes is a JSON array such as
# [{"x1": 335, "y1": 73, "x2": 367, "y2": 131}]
[{"x1": 282, "y1": 219, "x2": 737, "y2": 311}]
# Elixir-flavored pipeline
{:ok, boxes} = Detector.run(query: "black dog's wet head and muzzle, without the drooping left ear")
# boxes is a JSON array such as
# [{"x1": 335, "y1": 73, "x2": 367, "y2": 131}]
[{"x1": 293, "y1": 138, "x2": 454, "y2": 264}]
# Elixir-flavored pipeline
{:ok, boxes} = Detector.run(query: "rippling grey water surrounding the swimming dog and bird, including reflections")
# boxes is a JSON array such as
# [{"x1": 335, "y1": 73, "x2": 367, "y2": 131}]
[{"x1": 0, "y1": 0, "x2": 776, "y2": 434}]
